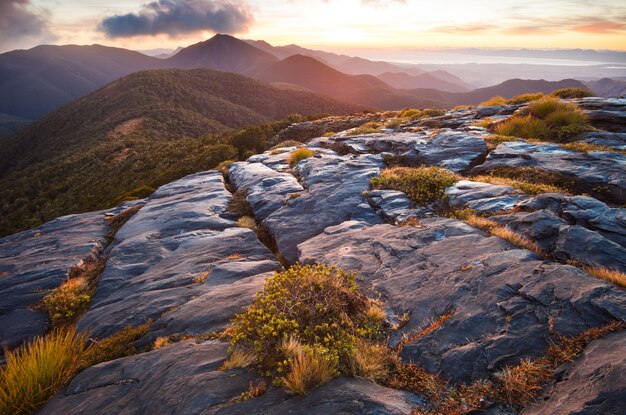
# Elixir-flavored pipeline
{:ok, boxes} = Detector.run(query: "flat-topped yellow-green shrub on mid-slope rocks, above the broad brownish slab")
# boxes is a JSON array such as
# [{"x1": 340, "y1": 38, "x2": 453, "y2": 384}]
[{"x1": 370, "y1": 167, "x2": 458, "y2": 205}]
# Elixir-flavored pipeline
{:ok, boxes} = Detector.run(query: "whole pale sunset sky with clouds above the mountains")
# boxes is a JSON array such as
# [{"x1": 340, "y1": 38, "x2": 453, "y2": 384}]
[{"x1": 0, "y1": 0, "x2": 626, "y2": 55}]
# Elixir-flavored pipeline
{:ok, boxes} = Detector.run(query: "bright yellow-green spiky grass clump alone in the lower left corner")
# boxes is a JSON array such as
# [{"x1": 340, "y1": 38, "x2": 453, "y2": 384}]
[{"x1": 0, "y1": 328, "x2": 87, "y2": 415}]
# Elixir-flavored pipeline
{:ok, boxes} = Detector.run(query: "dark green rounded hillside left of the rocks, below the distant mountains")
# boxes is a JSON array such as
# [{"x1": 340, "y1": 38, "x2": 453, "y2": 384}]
[{"x1": 0, "y1": 69, "x2": 358, "y2": 235}]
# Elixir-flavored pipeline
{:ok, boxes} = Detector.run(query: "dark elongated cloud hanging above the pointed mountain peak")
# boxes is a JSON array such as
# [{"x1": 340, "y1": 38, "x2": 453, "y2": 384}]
[{"x1": 97, "y1": 0, "x2": 254, "y2": 38}]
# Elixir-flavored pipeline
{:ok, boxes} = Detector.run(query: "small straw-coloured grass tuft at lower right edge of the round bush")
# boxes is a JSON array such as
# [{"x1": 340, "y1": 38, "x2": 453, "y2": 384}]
[{"x1": 346, "y1": 342, "x2": 392, "y2": 382}]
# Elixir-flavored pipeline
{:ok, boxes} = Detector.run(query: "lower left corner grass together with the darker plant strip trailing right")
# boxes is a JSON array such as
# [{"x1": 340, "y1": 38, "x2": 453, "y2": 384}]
[{"x1": 0, "y1": 322, "x2": 151, "y2": 415}]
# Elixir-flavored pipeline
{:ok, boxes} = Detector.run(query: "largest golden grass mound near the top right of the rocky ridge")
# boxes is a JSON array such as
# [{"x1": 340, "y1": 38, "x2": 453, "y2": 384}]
[{"x1": 495, "y1": 97, "x2": 591, "y2": 142}]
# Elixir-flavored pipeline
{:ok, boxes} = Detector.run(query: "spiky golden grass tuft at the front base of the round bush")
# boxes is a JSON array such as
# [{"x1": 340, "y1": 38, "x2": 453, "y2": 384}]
[{"x1": 281, "y1": 345, "x2": 337, "y2": 395}]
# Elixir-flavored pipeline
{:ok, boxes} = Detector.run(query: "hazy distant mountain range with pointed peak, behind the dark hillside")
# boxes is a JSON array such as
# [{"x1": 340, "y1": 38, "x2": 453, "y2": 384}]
[{"x1": 0, "y1": 35, "x2": 621, "y2": 134}]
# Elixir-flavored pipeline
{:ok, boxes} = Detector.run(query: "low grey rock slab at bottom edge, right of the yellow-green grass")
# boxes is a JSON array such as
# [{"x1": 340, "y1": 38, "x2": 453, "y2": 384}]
[{"x1": 38, "y1": 342, "x2": 256, "y2": 415}]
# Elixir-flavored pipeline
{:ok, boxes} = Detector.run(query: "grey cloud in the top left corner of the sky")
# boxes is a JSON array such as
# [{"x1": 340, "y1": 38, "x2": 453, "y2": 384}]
[{"x1": 0, "y1": 0, "x2": 53, "y2": 46}]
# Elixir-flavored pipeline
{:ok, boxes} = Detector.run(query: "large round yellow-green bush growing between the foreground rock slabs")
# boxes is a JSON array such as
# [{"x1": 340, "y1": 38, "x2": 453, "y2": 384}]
[{"x1": 226, "y1": 265, "x2": 384, "y2": 393}]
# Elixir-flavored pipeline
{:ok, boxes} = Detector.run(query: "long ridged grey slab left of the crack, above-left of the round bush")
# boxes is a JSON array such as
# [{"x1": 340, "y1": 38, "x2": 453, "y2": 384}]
[{"x1": 78, "y1": 171, "x2": 280, "y2": 337}]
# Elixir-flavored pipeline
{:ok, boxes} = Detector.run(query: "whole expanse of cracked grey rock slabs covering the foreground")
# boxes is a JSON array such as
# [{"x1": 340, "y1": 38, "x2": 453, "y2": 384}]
[{"x1": 0, "y1": 98, "x2": 626, "y2": 414}]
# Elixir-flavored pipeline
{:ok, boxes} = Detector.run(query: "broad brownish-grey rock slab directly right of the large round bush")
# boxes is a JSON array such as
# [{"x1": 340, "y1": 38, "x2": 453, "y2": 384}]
[{"x1": 299, "y1": 218, "x2": 626, "y2": 382}]
